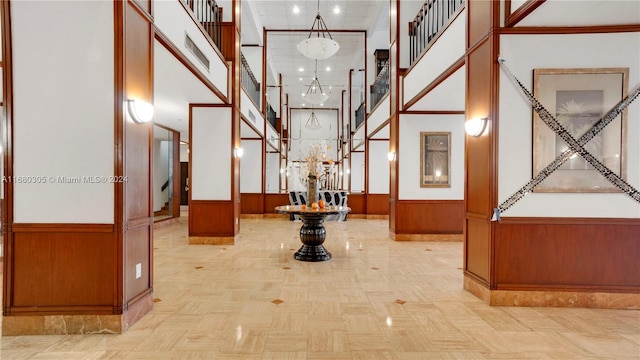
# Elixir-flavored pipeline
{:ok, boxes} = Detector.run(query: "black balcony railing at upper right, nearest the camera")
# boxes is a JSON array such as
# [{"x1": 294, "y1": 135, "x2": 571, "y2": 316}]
[{"x1": 409, "y1": 0, "x2": 464, "y2": 64}]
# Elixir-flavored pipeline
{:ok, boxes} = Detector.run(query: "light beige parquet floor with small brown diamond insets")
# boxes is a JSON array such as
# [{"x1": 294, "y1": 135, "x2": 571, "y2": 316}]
[{"x1": 0, "y1": 217, "x2": 640, "y2": 360}]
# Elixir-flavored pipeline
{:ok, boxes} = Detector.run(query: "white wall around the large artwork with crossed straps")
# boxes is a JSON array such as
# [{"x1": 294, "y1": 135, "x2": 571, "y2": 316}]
[{"x1": 496, "y1": 33, "x2": 640, "y2": 218}]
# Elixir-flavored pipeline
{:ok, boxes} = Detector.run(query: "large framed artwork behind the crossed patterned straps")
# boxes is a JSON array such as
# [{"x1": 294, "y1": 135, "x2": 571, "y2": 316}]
[{"x1": 533, "y1": 68, "x2": 629, "y2": 192}]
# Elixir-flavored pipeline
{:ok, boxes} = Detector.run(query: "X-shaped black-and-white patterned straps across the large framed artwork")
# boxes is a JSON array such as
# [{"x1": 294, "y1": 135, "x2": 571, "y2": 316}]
[{"x1": 491, "y1": 58, "x2": 640, "y2": 221}]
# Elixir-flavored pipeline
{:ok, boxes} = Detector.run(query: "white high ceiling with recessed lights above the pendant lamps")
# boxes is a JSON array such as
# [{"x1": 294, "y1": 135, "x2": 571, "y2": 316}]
[{"x1": 242, "y1": 0, "x2": 389, "y2": 108}]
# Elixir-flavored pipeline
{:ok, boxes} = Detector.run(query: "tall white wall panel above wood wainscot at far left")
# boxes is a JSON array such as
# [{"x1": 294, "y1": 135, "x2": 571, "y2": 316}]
[{"x1": 11, "y1": 1, "x2": 115, "y2": 224}]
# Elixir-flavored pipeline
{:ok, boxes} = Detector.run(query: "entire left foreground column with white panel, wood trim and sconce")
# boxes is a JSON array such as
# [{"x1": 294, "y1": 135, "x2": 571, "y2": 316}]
[{"x1": 1, "y1": 1, "x2": 153, "y2": 336}]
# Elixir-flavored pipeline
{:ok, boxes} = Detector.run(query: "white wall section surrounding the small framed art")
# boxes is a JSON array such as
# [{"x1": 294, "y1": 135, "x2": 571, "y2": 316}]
[{"x1": 398, "y1": 114, "x2": 465, "y2": 200}]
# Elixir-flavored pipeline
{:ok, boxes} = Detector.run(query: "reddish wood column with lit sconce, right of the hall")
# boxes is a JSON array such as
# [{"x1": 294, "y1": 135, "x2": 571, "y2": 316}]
[{"x1": 464, "y1": 0, "x2": 500, "y2": 288}]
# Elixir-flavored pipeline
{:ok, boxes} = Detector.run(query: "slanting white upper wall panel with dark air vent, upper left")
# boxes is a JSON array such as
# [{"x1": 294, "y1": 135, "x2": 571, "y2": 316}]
[{"x1": 152, "y1": 1, "x2": 229, "y2": 95}]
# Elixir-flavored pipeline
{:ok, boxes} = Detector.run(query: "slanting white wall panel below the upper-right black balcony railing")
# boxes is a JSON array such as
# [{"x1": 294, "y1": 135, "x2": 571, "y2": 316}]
[{"x1": 403, "y1": 9, "x2": 467, "y2": 104}]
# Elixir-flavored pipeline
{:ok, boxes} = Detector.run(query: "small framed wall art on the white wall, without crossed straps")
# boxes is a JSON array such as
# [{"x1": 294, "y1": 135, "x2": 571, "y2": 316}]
[{"x1": 420, "y1": 132, "x2": 451, "y2": 187}]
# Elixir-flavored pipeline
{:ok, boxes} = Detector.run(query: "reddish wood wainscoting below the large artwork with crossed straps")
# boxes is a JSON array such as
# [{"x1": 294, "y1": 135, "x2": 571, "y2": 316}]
[{"x1": 492, "y1": 218, "x2": 640, "y2": 293}]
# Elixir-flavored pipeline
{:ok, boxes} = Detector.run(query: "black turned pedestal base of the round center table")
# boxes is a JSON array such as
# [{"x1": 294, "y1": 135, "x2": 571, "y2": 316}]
[{"x1": 293, "y1": 215, "x2": 331, "y2": 261}]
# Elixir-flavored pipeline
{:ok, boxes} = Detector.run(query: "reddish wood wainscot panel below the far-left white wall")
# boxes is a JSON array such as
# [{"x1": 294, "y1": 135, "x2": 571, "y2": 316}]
[{"x1": 4, "y1": 224, "x2": 121, "y2": 315}]
